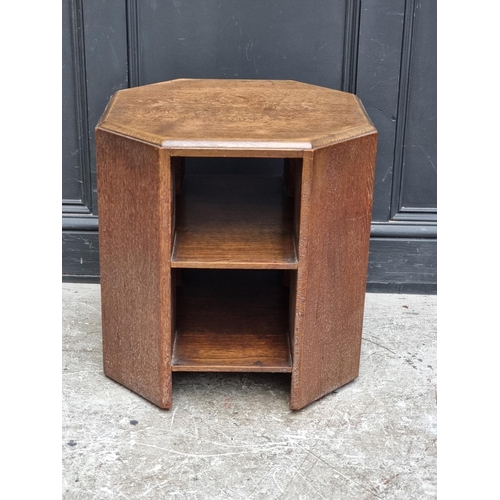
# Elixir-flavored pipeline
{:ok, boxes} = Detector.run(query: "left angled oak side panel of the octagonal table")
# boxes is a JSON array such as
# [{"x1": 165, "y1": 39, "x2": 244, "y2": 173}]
[{"x1": 97, "y1": 130, "x2": 172, "y2": 408}]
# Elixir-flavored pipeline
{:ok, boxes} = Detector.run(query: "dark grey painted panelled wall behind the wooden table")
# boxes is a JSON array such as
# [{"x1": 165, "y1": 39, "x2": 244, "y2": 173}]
[{"x1": 62, "y1": 0, "x2": 437, "y2": 293}]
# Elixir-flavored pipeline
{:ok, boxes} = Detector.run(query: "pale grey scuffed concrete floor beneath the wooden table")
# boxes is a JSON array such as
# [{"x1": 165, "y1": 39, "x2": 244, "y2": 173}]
[{"x1": 62, "y1": 284, "x2": 436, "y2": 500}]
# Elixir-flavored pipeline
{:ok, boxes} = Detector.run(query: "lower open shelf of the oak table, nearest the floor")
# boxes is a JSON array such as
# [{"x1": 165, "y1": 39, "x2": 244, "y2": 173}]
[{"x1": 172, "y1": 270, "x2": 292, "y2": 372}]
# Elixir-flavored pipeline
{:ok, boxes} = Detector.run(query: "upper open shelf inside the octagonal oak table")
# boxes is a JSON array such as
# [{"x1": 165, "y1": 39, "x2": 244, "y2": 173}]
[{"x1": 171, "y1": 174, "x2": 297, "y2": 269}]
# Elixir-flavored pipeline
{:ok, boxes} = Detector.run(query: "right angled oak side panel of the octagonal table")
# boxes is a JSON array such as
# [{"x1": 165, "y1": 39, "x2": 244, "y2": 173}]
[{"x1": 290, "y1": 134, "x2": 377, "y2": 409}]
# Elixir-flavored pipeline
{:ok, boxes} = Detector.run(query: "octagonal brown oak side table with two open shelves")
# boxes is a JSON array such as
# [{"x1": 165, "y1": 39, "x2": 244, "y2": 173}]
[{"x1": 96, "y1": 79, "x2": 377, "y2": 410}]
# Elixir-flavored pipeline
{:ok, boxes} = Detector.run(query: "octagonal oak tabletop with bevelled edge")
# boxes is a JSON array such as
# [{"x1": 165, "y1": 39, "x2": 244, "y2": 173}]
[{"x1": 98, "y1": 79, "x2": 375, "y2": 150}]
